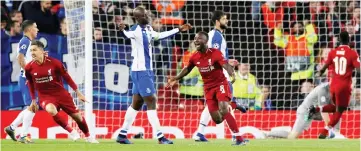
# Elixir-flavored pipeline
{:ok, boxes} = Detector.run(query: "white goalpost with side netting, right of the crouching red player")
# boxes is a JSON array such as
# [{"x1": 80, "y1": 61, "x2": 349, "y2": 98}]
[{"x1": 64, "y1": 0, "x2": 95, "y2": 135}]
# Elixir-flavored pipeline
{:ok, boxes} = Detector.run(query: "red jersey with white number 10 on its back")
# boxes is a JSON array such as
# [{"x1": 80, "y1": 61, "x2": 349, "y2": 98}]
[{"x1": 326, "y1": 45, "x2": 360, "y2": 86}]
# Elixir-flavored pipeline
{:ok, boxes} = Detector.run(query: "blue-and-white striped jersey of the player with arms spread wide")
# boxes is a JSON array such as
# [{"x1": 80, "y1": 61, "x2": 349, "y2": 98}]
[{"x1": 123, "y1": 24, "x2": 179, "y2": 71}]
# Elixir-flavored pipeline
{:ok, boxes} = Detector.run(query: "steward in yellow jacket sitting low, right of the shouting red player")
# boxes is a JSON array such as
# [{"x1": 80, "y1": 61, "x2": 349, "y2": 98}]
[{"x1": 233, "y1": 59, "x2": 263, "y2": 110}]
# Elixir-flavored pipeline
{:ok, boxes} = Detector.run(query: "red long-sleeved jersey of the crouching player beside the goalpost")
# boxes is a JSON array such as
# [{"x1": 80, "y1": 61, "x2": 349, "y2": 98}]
[{"x1": 25, "y1": 57, "x2": 77, "y2": 99}]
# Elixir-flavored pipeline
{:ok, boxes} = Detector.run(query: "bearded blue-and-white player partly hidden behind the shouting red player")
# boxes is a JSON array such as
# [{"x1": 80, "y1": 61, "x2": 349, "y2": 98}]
[{"x1": 194, "y1": 11, "x2": 247, "y2": 142}]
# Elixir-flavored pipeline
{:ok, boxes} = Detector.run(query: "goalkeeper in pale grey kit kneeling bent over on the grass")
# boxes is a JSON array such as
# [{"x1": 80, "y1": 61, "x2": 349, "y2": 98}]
[{"x1": 267, "y1": 83, "x2": 340, "y2": 139}]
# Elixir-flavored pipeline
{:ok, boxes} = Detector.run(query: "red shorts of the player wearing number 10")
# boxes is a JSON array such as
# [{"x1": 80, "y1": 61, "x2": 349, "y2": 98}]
[{"x1": 330, "y1": 84, "x2": 352, "y2": 107}]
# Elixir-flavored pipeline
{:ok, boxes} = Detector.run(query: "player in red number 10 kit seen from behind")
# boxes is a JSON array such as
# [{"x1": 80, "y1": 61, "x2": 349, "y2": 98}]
[{"x1": 309, "y1": 31, "x2": 360, "y2": 139}]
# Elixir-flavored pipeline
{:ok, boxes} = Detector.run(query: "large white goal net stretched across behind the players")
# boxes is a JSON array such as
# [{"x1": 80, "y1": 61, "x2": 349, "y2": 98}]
[{"x1": 66, "y1": 0, "x2": 360, "y2": 138}]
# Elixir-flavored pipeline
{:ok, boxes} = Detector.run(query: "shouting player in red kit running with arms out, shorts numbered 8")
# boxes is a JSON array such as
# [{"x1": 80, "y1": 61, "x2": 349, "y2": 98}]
[{"x1": 167, "y1": 32, "x2": 248, "y2": 145}]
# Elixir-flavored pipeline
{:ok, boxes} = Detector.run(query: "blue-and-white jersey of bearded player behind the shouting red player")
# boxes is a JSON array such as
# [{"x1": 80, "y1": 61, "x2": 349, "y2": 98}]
[{"x1": 208, "y1": 29, "x2": 230, "y2": 81}]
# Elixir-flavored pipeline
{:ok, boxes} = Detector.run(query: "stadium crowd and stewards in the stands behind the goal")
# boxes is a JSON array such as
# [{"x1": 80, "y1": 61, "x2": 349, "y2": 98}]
[{"x1": 1, "y1": 0, "x2": 361, "y2": 110}]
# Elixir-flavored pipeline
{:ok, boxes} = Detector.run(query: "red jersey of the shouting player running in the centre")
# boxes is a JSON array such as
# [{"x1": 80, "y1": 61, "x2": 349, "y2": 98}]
[{"x1": 188, "y1": 48, "x2": 227, "y2": 89}]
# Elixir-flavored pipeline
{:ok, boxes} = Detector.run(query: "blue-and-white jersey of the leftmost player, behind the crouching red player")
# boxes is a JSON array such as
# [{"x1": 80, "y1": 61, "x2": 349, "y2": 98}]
[{"x1": 17, "y1": 35, "x2": 33, "y2": 77}]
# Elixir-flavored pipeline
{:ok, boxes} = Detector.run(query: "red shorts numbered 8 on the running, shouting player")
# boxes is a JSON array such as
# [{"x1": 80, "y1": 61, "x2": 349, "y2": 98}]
[{"x1": 204, "y1": 81, "x2": 232, "y2": 112}]
